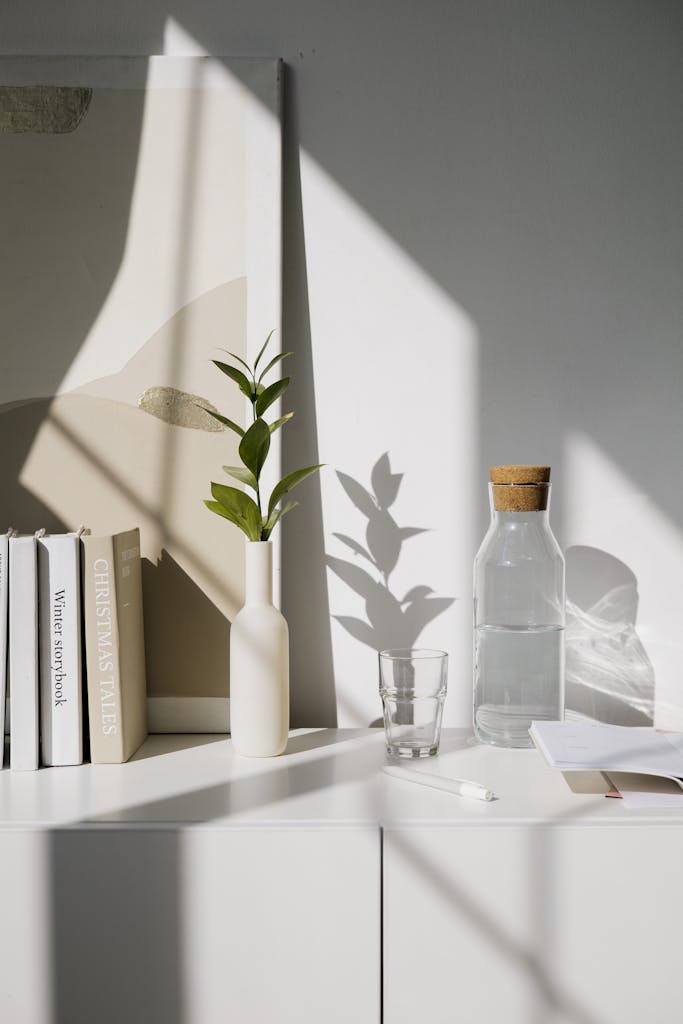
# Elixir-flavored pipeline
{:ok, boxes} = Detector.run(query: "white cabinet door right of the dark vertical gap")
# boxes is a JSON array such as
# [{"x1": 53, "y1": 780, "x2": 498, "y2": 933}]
[{"x1": 383, "y1": 823, "x2": 683, "y2": 1024}]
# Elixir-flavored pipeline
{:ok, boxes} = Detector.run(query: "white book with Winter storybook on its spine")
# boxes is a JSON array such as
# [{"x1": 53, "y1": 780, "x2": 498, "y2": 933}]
[{"x1": 38, "y1": 534, "x2": 83, "y2": 766}]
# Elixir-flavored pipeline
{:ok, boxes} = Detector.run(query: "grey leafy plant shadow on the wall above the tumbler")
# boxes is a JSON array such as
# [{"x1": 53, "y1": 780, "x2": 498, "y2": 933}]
[{"x1": 326, "y1": 453, "x2": 455, "y2": 724}]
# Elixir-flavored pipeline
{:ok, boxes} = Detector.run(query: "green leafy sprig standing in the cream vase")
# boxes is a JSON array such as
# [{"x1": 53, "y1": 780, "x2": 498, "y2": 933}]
[{"x1": 203, "y1": 331, "x2": 321, "y2": 541}]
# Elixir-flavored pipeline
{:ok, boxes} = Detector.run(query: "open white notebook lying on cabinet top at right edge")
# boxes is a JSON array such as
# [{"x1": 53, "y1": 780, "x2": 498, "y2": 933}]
[{"x1": 529, "y1": 722, "x2": 683, "y2": 806}]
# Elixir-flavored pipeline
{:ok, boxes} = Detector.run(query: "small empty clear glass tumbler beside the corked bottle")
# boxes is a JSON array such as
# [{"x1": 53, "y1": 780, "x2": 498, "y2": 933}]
[{"x1": 379, "y1": 648, "x2": 449, "y2": 758}]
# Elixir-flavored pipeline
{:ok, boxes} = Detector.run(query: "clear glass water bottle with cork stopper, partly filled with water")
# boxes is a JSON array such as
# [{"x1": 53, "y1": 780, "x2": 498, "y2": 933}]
[{"x1": 474, "y1": 466, "x2": 564, "y2": 746}]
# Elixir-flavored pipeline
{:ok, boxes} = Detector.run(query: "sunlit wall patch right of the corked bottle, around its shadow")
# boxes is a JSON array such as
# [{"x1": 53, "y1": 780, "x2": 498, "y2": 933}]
[{"x1": 563, "y1": 432, "x2": 683, "y2": 730}]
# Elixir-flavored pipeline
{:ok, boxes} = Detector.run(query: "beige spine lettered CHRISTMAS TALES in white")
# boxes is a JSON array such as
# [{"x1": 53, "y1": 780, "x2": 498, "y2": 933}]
[{"x1": 83, "y1": 537, "x2": 124, "y2": 764}]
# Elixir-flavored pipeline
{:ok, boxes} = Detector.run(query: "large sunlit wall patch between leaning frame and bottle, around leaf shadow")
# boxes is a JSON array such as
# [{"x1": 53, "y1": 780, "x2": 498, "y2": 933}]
[{"x1": 301, "y1": 154, "x2": 479, "y2": 726}]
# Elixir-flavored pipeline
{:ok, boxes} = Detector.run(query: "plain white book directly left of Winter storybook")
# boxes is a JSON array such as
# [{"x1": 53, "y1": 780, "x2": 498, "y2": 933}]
[{"x1": 9, "y1": 537, "x2": 39, "y2": 771}]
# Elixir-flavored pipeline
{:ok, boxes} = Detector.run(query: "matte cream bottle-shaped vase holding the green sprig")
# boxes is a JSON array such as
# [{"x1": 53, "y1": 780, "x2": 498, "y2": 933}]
[{"x1": 230, "y1": 541, "x2": 290, "y2": 758}]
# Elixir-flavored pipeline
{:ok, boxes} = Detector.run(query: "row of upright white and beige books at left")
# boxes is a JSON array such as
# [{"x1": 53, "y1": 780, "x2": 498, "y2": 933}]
[{"x1": 0, "y1": 528, "x2": 147, "y2": 771}]
